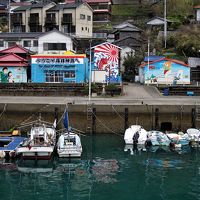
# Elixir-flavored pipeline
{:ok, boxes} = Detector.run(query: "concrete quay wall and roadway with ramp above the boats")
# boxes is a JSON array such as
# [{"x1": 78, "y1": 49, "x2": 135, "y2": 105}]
[{"x1": 0, "y1": 84, "x2": 200, "y2": 133}]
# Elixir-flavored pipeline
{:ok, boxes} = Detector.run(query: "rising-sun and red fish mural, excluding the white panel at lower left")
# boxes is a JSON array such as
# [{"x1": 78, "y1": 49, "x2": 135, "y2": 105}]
[{"x1": 94, "y1": 43, "x2": 120, "y2": 83}]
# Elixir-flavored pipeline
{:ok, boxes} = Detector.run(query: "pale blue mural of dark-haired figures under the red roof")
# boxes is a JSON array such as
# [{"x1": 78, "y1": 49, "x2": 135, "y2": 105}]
[{"x1": 0, "y1": 67, "x2": 27, "y2": 83}]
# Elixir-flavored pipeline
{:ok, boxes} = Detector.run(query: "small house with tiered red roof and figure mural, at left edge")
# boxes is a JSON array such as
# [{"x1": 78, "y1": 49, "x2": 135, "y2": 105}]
[{"x1": 0, "y1": 53, "x2": 28, "y2": 83}]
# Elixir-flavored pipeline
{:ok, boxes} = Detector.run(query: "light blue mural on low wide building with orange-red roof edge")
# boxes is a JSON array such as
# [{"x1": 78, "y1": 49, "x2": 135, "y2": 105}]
[{"x1": 144, "y1": 60, "x2": 190, "y2": 85}]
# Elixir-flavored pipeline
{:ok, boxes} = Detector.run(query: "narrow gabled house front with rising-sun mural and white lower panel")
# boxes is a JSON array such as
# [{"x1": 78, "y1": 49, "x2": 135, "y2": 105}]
[{"x1": 92, "y1": 42, "x2": 121, "y2": 83}]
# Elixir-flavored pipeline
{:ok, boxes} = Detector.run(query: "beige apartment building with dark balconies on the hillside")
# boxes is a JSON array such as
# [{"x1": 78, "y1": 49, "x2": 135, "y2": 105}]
[{"x1": 11, "y1": 2, "x2": 93, "y2": 38}]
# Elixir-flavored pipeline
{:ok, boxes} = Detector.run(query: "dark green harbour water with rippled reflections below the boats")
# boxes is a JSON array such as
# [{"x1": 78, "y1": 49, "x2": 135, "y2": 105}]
[{"x1": 0, "y1": 135, "x2": 200, "y2": 200}]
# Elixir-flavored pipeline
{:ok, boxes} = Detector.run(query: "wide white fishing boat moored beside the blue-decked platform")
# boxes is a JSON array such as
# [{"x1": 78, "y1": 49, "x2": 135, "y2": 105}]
[{"x1": 17, "y1": 119, "x2": 56, "y2": 159}]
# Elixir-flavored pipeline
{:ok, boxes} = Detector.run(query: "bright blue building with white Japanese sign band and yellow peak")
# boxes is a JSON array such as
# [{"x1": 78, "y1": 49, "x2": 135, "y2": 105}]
[{"x1": 31, "y1": 51, "x2": 88, "y2": 83}]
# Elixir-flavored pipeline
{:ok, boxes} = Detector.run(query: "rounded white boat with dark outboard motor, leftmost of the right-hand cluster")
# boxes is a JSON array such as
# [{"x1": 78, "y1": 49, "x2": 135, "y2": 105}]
[{"x1": 124, "y1": 125, "x2": 147, "y2": 145}]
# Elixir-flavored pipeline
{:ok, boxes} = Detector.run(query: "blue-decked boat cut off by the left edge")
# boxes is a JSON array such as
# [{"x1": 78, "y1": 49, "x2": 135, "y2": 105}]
[{"x1": 0, "y1": 130, "x2": 26, "y2": 158}]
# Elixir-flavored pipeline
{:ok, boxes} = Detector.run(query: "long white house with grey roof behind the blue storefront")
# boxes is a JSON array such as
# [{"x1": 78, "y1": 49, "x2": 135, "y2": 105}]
[{"x1": 0, "y1": 29, "x2": 75, "y2": 54}]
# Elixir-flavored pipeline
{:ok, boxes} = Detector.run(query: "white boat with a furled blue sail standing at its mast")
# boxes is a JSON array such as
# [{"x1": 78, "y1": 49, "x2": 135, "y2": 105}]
[{"x1": 57, "y1": 112, "x2": 82, "y2": 158}]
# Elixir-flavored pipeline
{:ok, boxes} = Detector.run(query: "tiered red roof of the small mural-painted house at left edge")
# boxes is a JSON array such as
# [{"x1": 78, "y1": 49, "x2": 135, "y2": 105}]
[{"x1": 0, "y1": 53, "x2": 28, "y2": 66}]
